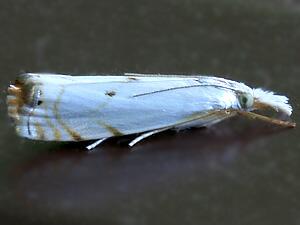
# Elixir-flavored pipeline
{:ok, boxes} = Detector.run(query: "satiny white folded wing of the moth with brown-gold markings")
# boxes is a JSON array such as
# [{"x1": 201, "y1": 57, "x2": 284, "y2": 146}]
[{"x1": 8, "y1": 74, "x2": 236, "y2": 141}]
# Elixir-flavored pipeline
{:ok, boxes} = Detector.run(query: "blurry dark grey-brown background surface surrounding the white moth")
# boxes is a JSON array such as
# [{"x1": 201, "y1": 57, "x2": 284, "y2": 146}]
[{"x1": 0, "y1": 0, "x2": 300, "y2": 225}]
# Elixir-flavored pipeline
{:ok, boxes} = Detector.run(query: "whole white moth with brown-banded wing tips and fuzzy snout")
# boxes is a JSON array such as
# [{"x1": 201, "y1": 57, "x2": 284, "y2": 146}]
[{"x1": 7, "y1": 73, "x2": 295, "y2": 149}]
